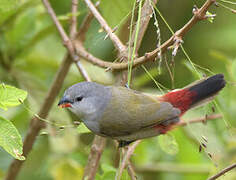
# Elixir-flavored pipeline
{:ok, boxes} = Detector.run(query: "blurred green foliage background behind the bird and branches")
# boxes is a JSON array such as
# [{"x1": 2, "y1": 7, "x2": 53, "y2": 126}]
[{"x1": 0, "y1": 0, "x2": 236, "y2": 180}]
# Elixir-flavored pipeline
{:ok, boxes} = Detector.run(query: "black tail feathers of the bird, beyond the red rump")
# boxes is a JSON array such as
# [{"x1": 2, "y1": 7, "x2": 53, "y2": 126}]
[{"x1": 187, "y1": 74, "x2": 226, "y2": 106}]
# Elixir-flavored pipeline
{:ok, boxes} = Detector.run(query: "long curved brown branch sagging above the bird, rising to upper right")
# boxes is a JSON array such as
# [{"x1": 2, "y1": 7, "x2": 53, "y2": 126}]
[{"x1": 75, "y1": 0, "x2": 215, "y2": 70}]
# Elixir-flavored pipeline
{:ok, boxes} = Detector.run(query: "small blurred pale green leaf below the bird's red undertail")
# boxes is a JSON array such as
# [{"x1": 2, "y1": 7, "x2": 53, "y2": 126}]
[{"x1": 158, "y1": 134, "x2": 179, "y2": 155}]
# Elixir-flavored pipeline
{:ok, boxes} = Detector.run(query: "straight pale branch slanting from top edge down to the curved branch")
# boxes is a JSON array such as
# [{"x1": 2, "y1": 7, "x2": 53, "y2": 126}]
[{"x1": 84, "y1": 0, "x2": 126, "y2": 56}]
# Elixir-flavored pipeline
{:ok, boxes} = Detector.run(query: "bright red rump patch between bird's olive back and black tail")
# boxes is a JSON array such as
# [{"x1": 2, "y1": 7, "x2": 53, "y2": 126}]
[{"x1": 161, "y1": 89, "x2": 197, "y2": 116}]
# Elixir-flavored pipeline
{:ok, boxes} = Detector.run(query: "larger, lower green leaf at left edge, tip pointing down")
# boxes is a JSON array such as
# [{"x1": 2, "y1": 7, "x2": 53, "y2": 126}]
[{"x1": 0, "y1": 116, "x2": 25, "y2": 160}]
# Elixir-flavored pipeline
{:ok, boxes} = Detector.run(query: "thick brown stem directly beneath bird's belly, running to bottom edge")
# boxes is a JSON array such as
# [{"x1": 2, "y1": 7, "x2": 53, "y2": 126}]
[{"x1": 83, "y1": 135, "x2": 106, "y2": 180}]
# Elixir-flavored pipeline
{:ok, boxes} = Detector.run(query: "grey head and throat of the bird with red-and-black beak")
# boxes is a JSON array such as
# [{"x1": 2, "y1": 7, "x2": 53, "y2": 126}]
[{"x1": 58, "y1": 82, "x2": 111, "y2": 132}]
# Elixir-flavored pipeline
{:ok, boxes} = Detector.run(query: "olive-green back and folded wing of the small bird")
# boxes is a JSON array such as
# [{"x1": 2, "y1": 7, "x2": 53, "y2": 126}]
[{"x1": 99, "y1": 87, "x2": 180, "y2": 137}]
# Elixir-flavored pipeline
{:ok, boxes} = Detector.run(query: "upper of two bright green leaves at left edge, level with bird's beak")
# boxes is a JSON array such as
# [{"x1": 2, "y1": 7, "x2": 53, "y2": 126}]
[{"x1": 0, "y1": 84, "x2": 27, "y2": 110}]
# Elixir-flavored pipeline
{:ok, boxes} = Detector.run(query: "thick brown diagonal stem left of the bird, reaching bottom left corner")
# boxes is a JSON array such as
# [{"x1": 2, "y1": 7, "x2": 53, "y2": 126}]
[{"x1": 6, "y1": 56, "x2": 71, "y2": 180}]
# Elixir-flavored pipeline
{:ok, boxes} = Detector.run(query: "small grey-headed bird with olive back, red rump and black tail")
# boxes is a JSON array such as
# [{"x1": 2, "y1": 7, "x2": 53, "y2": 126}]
[{"x1": 58, "y1": 74, "x2": 226, "y2": 147}]
